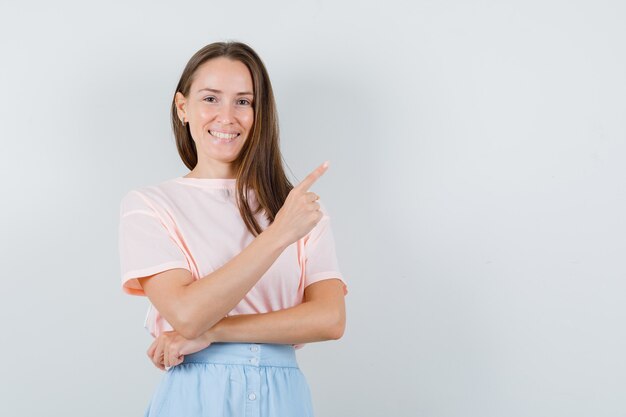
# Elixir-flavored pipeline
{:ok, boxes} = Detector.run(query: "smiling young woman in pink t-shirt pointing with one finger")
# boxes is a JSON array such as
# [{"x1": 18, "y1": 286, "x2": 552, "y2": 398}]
[{"x1": 119, "y1": 42, "x2": 347, "y2": 417}]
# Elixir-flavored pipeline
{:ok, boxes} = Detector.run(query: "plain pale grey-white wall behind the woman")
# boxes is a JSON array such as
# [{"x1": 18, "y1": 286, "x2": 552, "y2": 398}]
[{"x1": 0, "y1": 0, "x2": 626, "y2": 417}]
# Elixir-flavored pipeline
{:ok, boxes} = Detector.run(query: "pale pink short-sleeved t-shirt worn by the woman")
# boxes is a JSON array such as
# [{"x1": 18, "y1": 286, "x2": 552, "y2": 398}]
[{"x1": 119, "y1": 177, "x2": 347, "y2": 349}]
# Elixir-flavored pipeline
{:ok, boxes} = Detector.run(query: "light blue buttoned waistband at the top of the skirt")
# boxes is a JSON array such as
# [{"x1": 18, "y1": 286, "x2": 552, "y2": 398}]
[{"x1": 182, "y1": 342, "x2": 298, "y2": 368}]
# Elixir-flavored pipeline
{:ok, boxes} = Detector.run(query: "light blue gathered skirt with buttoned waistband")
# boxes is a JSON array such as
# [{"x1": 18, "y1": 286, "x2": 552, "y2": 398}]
[{"x1": 144, "y1": 342, "x2": 313, "y2": 417}]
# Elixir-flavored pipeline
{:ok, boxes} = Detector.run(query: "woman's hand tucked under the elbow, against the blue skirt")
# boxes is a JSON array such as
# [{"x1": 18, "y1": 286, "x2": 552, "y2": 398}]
[{"x1": 146, "y1": 330, "x2": 211, "y2": 371}]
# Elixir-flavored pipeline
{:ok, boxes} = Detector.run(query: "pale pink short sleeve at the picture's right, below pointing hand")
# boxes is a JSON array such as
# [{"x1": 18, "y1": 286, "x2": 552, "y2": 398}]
[{"x1": 304, "y1": 200, "x2": 348, "y2": 295}]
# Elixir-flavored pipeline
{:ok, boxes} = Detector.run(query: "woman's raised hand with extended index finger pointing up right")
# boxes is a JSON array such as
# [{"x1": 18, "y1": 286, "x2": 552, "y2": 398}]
[{"x1": 268, "y1": 161, "x2": 328, "y2": 245}]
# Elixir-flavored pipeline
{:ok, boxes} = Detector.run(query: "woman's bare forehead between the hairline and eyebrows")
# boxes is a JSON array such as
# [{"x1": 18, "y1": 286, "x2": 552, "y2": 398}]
[{"x1": 191, "y1": 57, "x2": 253, "y2": 93}]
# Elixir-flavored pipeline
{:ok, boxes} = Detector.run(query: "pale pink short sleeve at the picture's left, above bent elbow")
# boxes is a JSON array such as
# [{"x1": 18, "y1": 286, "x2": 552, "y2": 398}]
[{"x1": 119, "y1": 190, "x2": 190, "y2": 296}]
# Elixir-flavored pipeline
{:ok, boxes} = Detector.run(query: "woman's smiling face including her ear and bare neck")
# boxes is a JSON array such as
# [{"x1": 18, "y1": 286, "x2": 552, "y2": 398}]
[{"x1": 176, "y1": 57, "x2": 254, "y2": 178}]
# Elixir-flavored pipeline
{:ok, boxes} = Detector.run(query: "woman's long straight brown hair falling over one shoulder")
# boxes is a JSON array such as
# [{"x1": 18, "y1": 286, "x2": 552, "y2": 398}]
[{"x1": 171, "y1": 41, "x2": 293, "y2": 236}]
